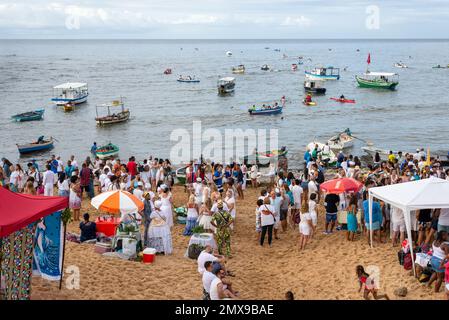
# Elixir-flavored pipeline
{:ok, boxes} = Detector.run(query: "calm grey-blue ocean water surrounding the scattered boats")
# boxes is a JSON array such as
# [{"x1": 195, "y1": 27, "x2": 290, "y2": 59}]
[{"x1": 0, "y1": 40, "x2": 449, "y2": 163}]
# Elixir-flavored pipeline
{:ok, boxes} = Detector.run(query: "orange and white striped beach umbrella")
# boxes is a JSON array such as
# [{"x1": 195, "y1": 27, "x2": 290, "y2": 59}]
[{"x1": 90, "y1": 190, "x2": 143, "y2": 214}]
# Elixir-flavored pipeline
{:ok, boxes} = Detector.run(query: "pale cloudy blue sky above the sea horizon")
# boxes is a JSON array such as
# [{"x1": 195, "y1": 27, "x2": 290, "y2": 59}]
[{"x1": 0, "y1": 0, "x2": 449, "y2": 39}]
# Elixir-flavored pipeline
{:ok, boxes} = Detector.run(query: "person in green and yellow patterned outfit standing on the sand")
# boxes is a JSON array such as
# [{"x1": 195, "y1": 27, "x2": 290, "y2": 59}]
[{"x1": 211, "y1": 200, "x2": 233, "y2": 257}]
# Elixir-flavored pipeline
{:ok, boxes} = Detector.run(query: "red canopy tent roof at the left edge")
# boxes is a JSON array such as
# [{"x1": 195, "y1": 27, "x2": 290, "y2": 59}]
[{"x1": 0, "y1": 187, "x2": 69, "y2": 238}]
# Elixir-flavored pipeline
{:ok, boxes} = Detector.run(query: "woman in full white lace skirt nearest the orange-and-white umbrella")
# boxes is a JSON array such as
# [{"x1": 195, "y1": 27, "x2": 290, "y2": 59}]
[{"x1": 148, "y1": 200, "x2": 173, "y2": 255}]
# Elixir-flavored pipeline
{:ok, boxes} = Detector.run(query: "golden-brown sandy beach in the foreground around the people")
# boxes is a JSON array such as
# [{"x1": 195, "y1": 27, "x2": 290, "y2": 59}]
[{"x1": 32, "y1": 186, "x2": 445, "y2": 300}]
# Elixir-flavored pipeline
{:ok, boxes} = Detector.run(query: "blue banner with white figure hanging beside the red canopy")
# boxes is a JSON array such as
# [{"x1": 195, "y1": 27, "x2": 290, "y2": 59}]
[{"x1": 33, "y1": 211, "x2": 64, "y2": 281}]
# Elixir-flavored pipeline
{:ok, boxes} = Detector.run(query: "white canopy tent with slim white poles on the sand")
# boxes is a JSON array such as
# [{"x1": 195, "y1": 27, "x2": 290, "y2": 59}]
[{"x1": 368, "y1": 177, "x2": 449, "y2": 272}]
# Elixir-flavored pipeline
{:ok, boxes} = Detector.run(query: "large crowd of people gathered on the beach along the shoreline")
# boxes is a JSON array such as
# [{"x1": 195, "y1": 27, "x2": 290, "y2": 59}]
[{"x1": 0, "y1": 144, "x2": 449, "y2": 299}]
